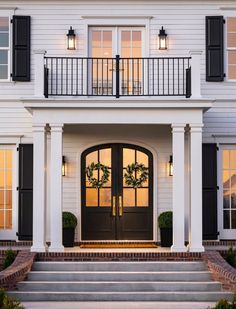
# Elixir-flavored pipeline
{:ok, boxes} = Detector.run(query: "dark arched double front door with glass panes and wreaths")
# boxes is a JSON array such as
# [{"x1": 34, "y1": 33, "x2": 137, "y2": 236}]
[{"x1": 81, "y1": 144, "x2": 153, "y2": 240}]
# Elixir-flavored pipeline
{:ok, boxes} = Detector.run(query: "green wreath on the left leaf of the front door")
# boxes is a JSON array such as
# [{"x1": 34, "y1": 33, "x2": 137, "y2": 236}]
[{"x1": 85, "y1": 162, "x2": 110, "y2": 189}]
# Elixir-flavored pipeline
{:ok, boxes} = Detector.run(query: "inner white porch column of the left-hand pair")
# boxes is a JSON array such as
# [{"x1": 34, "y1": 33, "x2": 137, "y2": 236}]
[{"x1": 49, "y1": 124, "x2": 64, "y2": 252}]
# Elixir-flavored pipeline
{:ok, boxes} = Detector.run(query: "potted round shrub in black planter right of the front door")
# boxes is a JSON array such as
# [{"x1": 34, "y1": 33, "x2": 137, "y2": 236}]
[{"x1": 158, "y1": 211, "x2": 173, "y2": 247}]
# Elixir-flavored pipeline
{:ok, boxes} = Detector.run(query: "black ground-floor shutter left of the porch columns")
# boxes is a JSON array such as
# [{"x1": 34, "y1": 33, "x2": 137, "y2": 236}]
[{"x1": 18, "y1": 144, "x2": 33, "y2": 240}]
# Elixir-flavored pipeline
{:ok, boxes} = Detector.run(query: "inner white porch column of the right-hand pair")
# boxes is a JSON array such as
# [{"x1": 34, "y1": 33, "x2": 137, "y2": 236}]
[{"x1": 171, "y1": 124, "x2": 187, "y2": 252}]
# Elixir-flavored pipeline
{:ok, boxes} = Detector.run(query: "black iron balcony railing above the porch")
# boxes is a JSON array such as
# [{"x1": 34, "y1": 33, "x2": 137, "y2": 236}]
[{"x1": 45, "y1": 55, "x2": 191, "y2": 98}]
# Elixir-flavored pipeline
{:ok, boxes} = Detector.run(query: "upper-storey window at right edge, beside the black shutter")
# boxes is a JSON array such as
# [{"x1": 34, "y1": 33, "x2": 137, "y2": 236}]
[{"x1": 227, "y1": 17, "x2": 236, "y2": 80}]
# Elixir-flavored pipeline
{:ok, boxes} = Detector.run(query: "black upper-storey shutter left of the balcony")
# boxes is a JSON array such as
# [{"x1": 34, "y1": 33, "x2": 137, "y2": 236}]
[{"x1": 12, "y1": 16, "x2": 30, "y2": 82}]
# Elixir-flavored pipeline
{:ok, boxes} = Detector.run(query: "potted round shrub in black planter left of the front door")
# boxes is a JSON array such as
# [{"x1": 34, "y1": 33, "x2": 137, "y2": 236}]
[{"x1": 62, "y1": 211, "x2": 77, "y2": 247}]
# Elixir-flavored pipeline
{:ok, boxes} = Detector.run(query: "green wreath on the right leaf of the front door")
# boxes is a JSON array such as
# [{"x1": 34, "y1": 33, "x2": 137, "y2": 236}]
[{"x1": 124, "y1": 162, "x2": 148, "y2": 189}]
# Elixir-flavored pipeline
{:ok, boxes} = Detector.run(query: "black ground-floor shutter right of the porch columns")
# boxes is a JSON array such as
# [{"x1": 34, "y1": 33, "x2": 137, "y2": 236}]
[{"x1": 202, "y1": 144, "x2": 218, "y2": 240}]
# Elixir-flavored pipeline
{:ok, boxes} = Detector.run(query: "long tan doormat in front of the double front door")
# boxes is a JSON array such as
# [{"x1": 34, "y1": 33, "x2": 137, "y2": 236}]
[{"x1": 80, "y1": 243, "x2": 158, "y2": 249}]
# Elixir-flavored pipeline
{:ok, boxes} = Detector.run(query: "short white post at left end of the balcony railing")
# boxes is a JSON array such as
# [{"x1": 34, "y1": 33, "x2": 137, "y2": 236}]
[{"x1": 34, "y1": 50, "x2": 46, "y2": 98}]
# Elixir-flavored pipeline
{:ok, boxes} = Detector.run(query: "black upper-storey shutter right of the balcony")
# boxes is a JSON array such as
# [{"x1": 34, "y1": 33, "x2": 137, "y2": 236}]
[{"x1": 206, "y1": 16, "x2": 224, "y2": 82}]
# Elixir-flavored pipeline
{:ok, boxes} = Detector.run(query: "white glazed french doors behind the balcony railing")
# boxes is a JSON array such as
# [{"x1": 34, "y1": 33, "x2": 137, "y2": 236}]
[{"x1": 89, "y1": 27, "x2": 145, "y2": 95}]
